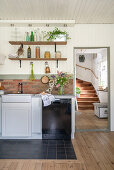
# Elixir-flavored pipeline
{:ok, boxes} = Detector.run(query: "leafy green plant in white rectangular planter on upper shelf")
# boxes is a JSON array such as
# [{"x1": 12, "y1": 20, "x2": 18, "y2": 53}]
[{"x1": 46, "y1": 27, "x2": 70, "y2": 41}]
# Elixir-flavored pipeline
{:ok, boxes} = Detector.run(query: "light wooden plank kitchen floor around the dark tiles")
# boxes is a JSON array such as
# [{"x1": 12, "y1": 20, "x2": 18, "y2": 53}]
[{"x1": 0, "y1": 132, "x2": 114, "y2": 170}]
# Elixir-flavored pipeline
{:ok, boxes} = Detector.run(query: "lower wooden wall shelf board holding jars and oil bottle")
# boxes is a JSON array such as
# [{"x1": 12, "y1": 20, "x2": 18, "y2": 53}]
[{"x1": 9, "y1": 58, "x2": 67, "y2": 61}]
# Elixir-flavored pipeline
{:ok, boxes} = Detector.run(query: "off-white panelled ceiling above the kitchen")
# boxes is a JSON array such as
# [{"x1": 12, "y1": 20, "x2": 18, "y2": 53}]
[{"x1": 0, "y1": 0, "x2": 114, "y2": 24}]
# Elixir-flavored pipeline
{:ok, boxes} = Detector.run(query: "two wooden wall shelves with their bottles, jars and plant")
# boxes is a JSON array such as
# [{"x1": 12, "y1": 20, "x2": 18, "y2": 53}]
[{"x1": 9, "y1": 28, "x2": 70, "y2": 67}]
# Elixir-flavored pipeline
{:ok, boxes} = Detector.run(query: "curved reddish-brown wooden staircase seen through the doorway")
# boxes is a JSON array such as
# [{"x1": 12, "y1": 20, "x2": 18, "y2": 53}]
[{"x1": 76, "y1": 79, "x2": 99, "y2": 110}]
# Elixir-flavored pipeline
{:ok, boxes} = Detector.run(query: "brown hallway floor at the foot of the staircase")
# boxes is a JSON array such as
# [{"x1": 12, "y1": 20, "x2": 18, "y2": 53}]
[{"x1": 76, "y1": 110, "x2": 108, "y2": 129}]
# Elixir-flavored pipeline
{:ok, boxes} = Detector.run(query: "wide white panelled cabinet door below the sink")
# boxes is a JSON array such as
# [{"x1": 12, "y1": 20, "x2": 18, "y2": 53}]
[{"x1": 2, "y1": 103, "x2": 31, "y2": 136}]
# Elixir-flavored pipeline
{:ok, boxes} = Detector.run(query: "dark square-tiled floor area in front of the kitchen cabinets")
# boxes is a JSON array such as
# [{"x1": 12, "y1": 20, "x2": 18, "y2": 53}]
[{"x1": 0, "y1": 140, "x2": 76, "y2": 159}]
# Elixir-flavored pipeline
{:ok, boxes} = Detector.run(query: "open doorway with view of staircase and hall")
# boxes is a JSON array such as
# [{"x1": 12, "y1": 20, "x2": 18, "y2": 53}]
[{"x1": 74, "y1": 47, "x2": 110, "y2": 131}]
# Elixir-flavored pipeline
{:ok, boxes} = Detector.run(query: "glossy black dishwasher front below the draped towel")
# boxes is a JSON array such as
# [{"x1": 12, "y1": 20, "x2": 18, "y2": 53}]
[{"x1": 42, "y1": 99, "x2": 71, "y2": 139}]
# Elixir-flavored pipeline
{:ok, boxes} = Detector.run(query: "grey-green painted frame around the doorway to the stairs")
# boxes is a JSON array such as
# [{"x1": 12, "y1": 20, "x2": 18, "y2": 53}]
[{"x1": 73, "y1": 46, "x2": 111, "y2": 132}]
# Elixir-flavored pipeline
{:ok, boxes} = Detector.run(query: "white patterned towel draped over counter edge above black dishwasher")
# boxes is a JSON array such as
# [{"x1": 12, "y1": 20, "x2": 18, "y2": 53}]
[{"x1": 41, "y1": 94, "x2": 55, "y2": 107}]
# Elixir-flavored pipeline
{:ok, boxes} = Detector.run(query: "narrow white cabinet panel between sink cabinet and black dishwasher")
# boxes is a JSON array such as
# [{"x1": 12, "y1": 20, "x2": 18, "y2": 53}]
[{"x1": 32, "y1": 97, "x2": 42, "y2": 134}]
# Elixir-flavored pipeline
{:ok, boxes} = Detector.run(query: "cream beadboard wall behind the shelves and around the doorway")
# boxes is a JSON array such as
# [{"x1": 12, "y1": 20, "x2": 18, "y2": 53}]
[{"x1": 0, "y1": 24, "x2": 114, "y2": 131}]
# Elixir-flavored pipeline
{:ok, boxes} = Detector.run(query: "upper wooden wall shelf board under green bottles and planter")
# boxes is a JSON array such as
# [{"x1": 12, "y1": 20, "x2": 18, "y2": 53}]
[{"x1": 9, "y1": 41, "x2": 67, "y2": 45}]
